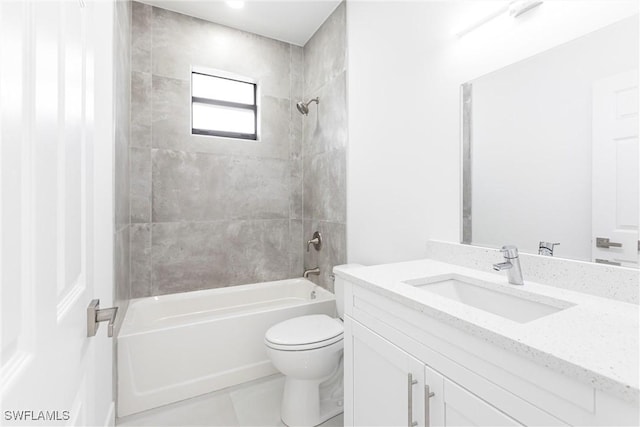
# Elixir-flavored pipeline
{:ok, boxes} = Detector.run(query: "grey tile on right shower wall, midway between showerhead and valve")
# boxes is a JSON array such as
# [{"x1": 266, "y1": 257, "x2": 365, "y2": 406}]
[{"x1": 303, "y1": 150, "x2": 347, "y2": 223}]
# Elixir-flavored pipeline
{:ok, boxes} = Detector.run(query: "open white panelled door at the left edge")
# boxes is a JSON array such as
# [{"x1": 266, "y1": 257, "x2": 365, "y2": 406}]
[{"x1": 0, "y1": 0, "x2": 113, "y2": 425}]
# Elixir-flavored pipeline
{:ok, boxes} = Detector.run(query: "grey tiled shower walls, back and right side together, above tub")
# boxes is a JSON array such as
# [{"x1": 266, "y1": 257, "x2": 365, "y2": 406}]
[{"x1": 129, "y1": 2, "x2": 347, "y2": 298}]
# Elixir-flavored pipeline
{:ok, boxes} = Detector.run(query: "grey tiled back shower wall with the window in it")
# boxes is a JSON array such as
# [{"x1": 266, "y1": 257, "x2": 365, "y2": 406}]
[{"x1": 130, "y1": 2, "x2": 303, "y2": 298}]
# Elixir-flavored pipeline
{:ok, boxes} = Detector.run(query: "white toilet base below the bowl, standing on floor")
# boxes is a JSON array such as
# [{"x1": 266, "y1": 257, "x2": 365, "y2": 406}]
[{"x1": 280, "y1": 358, "x2": 344, "y2": 427}]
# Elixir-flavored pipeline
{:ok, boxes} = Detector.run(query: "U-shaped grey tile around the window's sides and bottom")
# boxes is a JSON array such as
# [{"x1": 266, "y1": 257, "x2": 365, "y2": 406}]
[{"x1": 152, "y1": 75, "x2": 291, "y2": 159}]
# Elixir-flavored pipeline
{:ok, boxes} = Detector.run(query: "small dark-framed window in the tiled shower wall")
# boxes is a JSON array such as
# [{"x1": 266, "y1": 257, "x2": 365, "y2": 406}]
[{"x1": 191, "y1": 71, "x2": 258, "y2": 140}]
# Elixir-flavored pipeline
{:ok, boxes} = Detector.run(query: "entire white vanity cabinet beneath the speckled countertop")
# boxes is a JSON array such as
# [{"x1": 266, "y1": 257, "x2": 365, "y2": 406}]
[{"x1": 338, "y1": 279, "x2": 638, "y2": 427}]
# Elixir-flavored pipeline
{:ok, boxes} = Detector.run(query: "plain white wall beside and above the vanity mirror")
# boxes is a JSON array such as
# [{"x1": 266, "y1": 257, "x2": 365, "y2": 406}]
[{"x1": 347, "y1": 0, "x2": 638, "y2": 264}]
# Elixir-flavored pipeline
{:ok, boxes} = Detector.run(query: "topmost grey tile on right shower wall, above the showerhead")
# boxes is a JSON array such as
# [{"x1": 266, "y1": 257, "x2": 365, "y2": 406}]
[{"x1": 304, "y1": 2, "x2": 346, "y2": 97}]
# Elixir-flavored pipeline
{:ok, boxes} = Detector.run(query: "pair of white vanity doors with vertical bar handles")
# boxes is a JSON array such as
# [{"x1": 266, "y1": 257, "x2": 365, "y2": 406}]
[{"x1": 347, "y1": 319, "x2": 522, "y2": 427}]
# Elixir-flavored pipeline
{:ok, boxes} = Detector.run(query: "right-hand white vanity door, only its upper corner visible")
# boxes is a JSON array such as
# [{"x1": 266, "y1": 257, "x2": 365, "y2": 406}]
[{"x1": 442, "y1": 379, "x2": 522, "y2": 427}]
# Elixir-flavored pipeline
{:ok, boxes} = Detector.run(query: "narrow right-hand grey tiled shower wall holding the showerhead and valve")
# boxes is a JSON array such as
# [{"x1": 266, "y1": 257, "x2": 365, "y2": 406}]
[{"x1": 301, "y1": 2, "x2": 347, "y2": 290}]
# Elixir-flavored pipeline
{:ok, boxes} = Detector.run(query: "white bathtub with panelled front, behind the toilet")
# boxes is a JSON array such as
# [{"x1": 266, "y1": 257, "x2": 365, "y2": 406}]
[{"x1": 117, "y1": 279, "x2": 335, "y2": 417}]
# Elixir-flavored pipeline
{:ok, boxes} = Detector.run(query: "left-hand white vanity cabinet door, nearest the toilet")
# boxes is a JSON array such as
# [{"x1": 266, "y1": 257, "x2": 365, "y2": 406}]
[{"x1": 345, "y1": 322, "x2": 425, "y2": 426}]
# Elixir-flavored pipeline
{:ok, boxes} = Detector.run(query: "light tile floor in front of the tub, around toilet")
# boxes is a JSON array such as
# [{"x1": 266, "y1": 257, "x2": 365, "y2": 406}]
[{"x1": 116, "y1": 375, "x2": 344, "y2": 427}]
